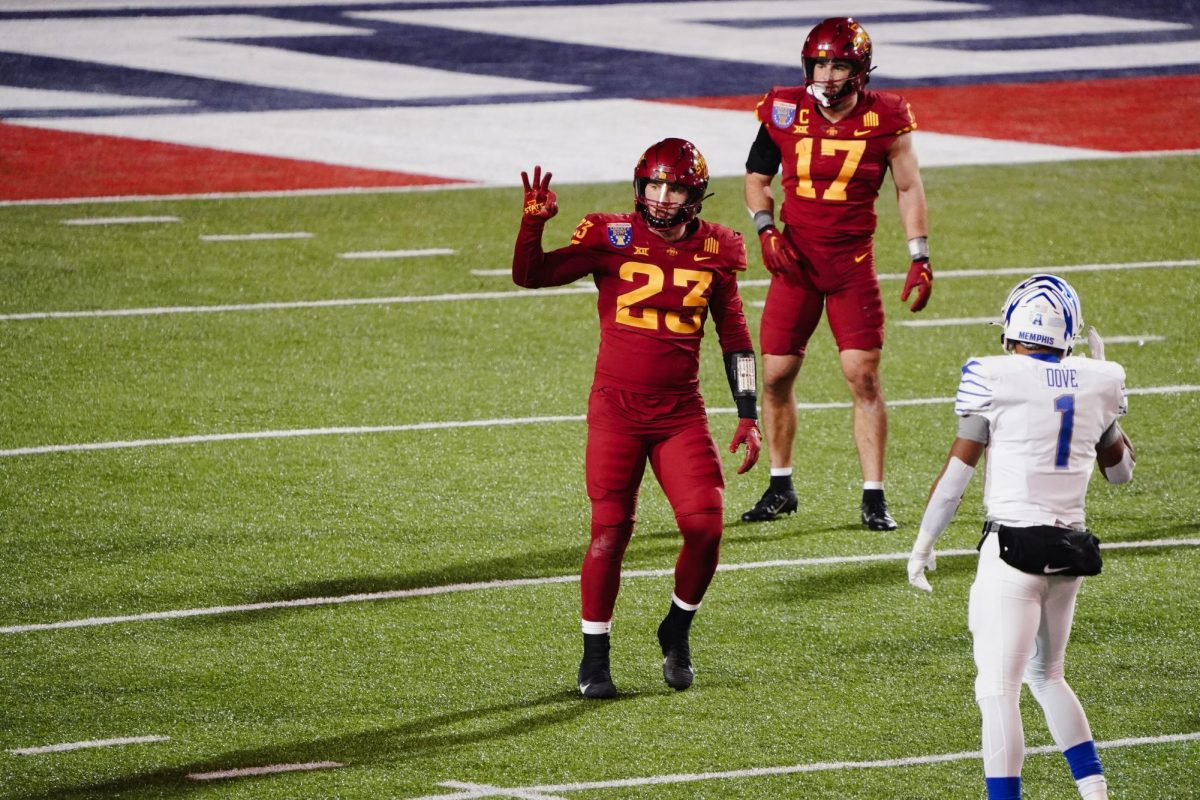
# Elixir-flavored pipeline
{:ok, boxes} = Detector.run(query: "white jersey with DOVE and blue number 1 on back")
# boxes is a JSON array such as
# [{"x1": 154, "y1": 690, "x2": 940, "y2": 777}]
[{"x1": 954, "y1": 355, "x2": 1127, "y2": 528}]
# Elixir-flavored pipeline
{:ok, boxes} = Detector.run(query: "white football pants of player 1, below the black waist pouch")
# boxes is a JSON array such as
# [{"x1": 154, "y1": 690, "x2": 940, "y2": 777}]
[{"x1": 968, "y1": 534, "x2": 1092, "y2": 777}]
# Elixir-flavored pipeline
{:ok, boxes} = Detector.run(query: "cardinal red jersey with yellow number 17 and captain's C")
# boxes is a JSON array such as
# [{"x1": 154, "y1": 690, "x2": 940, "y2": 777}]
[{"x1": 756, "y1": 86, "x2": 917, "y2": 241}]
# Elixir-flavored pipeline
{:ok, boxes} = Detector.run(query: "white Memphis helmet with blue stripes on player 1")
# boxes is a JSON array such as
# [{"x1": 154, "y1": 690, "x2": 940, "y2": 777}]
[{"x1": 1000, "y1": 273, "x2": 1084, "y2": 355}]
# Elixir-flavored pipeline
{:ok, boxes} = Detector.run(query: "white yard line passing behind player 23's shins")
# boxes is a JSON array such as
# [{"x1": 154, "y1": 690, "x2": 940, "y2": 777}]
[{"x1": 0, "y1": 539, "x2": 1200, "y2": 633}]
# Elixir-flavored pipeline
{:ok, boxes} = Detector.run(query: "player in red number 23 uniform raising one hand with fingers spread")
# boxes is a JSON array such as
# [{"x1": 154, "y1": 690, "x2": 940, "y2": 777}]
[{"x1": 512, "y1": 139, "x2": 761, "y2": 698}]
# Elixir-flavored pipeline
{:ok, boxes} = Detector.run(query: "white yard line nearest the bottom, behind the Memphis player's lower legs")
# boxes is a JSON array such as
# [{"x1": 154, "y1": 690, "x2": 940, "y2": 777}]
[{"x1": 412, "y1": 733, "x2": 1200, "y2": 800}]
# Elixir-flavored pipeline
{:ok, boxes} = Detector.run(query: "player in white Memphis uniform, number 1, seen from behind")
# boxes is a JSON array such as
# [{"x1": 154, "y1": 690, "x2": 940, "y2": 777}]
[{"x1": 908, "y1": 275, "x2": 1134, "y2": 800}]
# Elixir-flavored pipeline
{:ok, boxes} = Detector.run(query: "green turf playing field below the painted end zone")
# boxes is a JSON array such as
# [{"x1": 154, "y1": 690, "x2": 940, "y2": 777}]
[{"x1": 0, "y1": 157, "x2": 1200, "y2": 800}]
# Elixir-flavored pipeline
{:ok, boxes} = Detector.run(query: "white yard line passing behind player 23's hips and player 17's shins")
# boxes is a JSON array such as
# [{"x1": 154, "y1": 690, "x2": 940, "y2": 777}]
[{"x1": 0, "y1": 384, "x2": 1200, "y2": 458}]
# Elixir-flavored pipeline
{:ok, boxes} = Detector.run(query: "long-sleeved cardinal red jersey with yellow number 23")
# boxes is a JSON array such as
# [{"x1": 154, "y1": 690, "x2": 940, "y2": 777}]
[{"x1": 512, "y1": 213, "x2": 752, "y2": 395}]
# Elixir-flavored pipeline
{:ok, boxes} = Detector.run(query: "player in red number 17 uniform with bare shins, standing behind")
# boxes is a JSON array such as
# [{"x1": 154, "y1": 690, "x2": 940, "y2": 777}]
[{"x1": 742, "y1": 17, "x2": 934, "y2": 530}]
